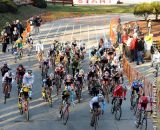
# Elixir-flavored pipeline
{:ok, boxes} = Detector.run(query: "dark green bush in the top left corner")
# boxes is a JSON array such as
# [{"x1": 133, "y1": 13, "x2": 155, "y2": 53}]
[{"x1": 0, "y1": 0, "x2": 18, "y2": 13}]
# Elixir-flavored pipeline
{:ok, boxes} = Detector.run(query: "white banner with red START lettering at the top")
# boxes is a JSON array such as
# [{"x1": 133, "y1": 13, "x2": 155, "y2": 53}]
[{"x1": 73, "y1": 0, "x2": 117, "y2": 5}]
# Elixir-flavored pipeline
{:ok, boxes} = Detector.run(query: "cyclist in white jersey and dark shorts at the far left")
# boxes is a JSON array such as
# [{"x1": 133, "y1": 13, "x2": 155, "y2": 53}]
[{"x1": 2, "y1": 71, "x2": 14, "y2": 97}]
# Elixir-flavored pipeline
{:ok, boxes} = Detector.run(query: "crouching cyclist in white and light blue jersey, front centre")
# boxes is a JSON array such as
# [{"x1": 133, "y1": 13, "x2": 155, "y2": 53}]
[{"x1": 89, "y1": 94, "x2": 105, "y2": 126}]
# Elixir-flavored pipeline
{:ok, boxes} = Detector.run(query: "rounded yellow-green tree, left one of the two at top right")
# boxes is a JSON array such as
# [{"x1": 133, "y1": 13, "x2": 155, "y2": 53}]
[{"x1": 134, "y1": 3, "x2": 153, "y2": 20}]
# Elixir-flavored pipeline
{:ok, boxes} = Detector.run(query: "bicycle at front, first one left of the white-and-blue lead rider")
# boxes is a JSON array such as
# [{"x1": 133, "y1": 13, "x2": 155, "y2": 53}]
[{"x1": 60, "y1": 100, "x2": 70, "y2": 125}]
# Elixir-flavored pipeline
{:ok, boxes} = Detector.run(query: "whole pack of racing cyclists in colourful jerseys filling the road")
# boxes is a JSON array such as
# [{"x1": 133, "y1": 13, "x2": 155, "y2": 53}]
[{"x1": 1, "y1": 36, "x2": 152, "y2": 126}]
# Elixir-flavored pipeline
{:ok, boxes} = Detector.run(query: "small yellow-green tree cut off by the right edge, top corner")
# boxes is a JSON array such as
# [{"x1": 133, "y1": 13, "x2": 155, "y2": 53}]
[{"x1": 151, "y1": 2, "x2": 160, "y2": 20}]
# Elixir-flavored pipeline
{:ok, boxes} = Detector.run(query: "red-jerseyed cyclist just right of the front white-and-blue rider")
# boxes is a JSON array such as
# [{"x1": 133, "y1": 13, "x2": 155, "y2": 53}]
[{"x1": 112, "y1": 84, "x2": 127, "y2": 106}]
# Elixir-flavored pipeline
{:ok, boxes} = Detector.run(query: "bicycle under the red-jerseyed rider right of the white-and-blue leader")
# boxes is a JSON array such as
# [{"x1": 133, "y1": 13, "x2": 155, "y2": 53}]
[{"x1": 111, "y1": 97, "x2": 122, "y2": 120}]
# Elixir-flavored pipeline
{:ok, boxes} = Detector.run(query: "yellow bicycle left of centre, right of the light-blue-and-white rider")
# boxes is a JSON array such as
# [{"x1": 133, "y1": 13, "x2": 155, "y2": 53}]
[{"x1": 42, "y1": 87, "x2": 52, "y2": 107}]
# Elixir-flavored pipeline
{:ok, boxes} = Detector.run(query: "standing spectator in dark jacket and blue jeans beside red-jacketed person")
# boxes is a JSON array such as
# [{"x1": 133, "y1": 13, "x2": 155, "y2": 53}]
[{"x1": 135, "y1": 37, "x2": 144, "y2": 65}]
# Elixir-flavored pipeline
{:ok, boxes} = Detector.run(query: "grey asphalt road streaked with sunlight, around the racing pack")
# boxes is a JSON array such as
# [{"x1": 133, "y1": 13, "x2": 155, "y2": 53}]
[{"x1": 0, "y1": 14, "x2": 153, "y2": 130}]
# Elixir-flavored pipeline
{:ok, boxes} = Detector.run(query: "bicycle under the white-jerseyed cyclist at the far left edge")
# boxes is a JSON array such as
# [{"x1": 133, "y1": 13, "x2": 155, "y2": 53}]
[{"x1": 3, "y1": 83, "x2": 11, "y2": 104}]
